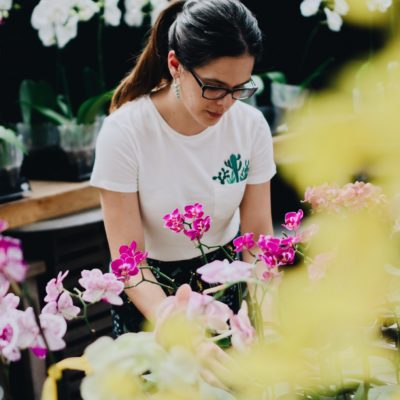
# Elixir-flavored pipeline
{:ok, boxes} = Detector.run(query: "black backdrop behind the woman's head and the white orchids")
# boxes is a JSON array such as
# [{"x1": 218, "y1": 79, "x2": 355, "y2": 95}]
[{"x1": 0, "y1": 0, "x2": 384, "y2": 125}]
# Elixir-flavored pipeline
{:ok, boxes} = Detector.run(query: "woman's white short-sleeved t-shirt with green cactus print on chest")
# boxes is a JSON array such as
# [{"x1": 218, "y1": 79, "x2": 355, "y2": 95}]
[{"x1": 91, "y1": 96, "x2": 276, "y2": 261}]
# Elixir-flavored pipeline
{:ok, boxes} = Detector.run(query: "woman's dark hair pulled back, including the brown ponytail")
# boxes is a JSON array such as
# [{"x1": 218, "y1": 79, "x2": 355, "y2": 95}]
[{"x1": 110, "y1": 0, "x2": 262, "y2": 111}]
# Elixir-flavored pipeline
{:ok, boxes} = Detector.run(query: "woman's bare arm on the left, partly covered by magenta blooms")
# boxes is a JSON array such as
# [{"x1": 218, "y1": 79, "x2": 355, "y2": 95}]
[{"x1": 100, "y1": 189, "x2": 166, "y2": 320}]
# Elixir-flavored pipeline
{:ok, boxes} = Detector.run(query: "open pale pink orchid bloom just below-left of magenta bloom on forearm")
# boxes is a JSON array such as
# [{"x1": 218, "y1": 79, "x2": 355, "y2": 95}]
[{"x1": 79, "y1": 268, "x2": 124, "y2": 306}]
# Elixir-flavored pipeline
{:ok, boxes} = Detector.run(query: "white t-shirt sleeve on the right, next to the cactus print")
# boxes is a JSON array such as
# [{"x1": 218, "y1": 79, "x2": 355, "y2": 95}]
[{"x1": 247, "y1": 116, "x2": 276, "y2": 184}]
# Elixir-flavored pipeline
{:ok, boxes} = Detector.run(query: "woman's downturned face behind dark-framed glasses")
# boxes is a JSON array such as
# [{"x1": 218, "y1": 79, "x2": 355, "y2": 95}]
[{"x1": 173, "y1": 55, "x2": 254, "y2": 128}]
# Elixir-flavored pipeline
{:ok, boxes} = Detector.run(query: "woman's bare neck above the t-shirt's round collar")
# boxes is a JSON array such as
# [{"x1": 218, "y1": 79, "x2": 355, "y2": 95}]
[{"x1": 151, "y1": 85, "x2": 205, "y2": 136}]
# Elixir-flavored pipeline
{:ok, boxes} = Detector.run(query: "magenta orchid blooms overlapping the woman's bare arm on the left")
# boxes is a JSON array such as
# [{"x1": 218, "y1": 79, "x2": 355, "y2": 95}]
[{"x1": 111, "y1": 241, "x2": 147, "y2": 282}]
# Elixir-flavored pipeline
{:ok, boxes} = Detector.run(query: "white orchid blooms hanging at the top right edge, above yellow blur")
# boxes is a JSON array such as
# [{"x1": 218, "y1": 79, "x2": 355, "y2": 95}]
[{"x1": 300, "y1": 0, "x2": 392, "y2": 32}]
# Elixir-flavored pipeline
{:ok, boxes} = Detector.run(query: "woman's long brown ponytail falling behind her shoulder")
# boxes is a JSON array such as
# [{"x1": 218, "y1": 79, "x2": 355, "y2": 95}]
[{"x1": 110, "y1": 0, "x2": 184, "y2": 112}]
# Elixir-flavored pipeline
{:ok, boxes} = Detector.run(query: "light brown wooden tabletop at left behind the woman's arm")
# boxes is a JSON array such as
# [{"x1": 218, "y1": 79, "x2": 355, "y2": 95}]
[{"x1": 0, "y1": 181, "x2": 100, "y2": 228}]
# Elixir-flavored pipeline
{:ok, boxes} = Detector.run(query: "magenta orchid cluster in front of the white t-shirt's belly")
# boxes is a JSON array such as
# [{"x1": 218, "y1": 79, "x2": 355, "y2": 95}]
[{"x1": 163, "y1": 203, "x2": 211, "y2": 240}]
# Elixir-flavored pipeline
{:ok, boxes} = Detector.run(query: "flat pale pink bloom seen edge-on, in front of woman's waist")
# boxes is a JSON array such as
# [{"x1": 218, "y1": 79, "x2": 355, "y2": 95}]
[{"x1": 197, "y1": 260, "x2": 253, "y2": 283}]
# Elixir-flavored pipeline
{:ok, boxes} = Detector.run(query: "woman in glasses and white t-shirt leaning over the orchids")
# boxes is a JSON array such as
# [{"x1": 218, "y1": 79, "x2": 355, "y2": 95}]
[{"x1": 91, "y1": 0, "x2": 276, "y2": 335}]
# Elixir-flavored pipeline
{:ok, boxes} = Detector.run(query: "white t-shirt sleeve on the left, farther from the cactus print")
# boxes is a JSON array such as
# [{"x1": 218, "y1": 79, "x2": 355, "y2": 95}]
[{"x1": 90, "y1": 117, "x2": 138, "y2": 193}]
